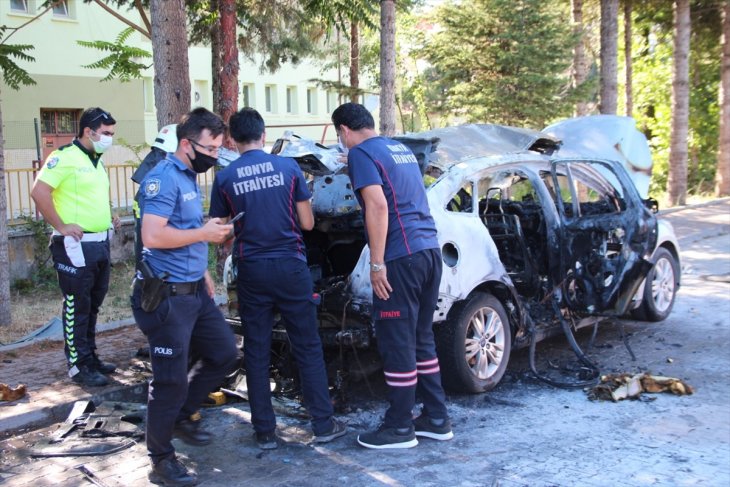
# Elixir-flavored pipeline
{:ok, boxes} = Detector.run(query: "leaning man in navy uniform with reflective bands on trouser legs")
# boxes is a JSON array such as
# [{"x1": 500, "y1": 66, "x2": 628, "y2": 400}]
[{"x1": 332, "y1": 103, "x2": 454, "y2": 449}]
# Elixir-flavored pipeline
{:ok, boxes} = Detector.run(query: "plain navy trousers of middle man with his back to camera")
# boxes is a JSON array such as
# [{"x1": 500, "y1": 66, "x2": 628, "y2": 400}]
[{"x1": 238, "y1": 258, "x2": 333, "y2": 435}]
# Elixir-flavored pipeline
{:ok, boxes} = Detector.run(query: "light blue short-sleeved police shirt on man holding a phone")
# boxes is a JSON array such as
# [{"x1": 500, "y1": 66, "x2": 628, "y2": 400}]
[{"x1": 140, "y1": 154, "x2": 208, "y2": 282}]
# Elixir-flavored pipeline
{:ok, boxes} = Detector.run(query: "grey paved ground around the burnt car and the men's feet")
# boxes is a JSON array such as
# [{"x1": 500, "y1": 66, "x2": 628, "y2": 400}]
[{"x1": 0, "y1": 199, "x2": 730, "y2": 487}]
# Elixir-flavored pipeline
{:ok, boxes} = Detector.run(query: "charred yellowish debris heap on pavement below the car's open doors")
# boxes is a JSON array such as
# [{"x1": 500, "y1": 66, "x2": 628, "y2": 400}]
[{"x1": 588, "y1": 373, "x2": 694, "y2": 402}]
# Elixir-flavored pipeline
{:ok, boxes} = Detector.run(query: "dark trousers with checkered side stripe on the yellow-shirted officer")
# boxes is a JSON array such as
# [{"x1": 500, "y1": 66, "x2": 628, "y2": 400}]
[{"x1": 50, "y1": 236, "x2": 111, "y2": 368}]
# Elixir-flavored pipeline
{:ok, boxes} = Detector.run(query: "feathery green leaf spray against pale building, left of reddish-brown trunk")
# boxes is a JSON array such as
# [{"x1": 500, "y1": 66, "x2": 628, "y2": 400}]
[{"x1": 76, "y1": 27, "x2": 152, "y2": 82}]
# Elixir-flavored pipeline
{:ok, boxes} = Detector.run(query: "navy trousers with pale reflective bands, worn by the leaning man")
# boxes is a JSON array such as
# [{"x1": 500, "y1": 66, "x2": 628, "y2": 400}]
[{"x1": 373, "y1": 249, "x2": 447, "y2": 428}]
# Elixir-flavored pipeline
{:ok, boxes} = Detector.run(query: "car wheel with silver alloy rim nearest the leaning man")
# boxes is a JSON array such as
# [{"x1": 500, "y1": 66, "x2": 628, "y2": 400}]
[{"x1": 434, "y1": 293, "x2": 512, "y2": 393}]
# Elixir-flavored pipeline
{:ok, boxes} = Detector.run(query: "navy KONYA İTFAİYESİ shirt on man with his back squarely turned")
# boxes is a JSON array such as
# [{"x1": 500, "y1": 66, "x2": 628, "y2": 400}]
[{"x1": 210, "y1": 150, "x2": 312, "y2": 262}]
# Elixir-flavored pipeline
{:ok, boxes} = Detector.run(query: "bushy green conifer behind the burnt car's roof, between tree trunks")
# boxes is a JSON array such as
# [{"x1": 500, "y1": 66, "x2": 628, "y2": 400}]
[{"x1": 422, "y1": 0, "x2": 576, "y2": 128}]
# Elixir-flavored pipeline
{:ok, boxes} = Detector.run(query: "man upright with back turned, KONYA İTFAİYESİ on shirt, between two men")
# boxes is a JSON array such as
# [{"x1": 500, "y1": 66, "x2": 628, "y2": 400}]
[{"x1": 210, "y1": 108, "x2": 347, "y2": 449}]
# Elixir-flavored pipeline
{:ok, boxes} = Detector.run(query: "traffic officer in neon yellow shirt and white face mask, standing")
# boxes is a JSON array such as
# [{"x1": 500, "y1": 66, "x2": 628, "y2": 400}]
[{"x1": 31, "y1": 107, "x2": 119, "y2": 386}]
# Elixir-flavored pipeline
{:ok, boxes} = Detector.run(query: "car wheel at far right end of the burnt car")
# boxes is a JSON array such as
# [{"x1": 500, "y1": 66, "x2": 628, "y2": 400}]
[{"x1": 632, "y1": 247, "x2": 679, "y2": 322}]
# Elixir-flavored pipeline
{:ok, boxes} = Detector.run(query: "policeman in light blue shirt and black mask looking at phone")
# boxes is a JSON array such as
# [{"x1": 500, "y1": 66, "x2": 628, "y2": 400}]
[{"x1": 132, "y1": 108, "x2": 238, "y2": 485}]
